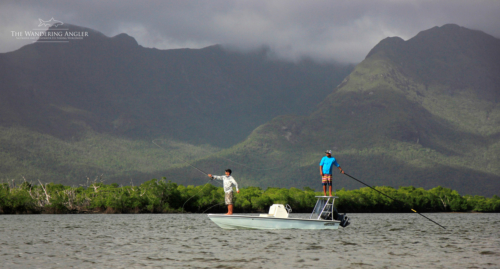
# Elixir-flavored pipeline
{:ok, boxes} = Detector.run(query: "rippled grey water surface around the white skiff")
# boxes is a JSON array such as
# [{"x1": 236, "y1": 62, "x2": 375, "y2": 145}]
[{"x1": 0, "y1": 214, "x2": 500, "y2": 268}]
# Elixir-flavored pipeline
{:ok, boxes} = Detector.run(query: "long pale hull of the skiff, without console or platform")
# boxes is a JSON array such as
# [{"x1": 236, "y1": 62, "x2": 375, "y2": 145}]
[{"x1": 208, "y1": 214, "x2": 340, "y2": 230}]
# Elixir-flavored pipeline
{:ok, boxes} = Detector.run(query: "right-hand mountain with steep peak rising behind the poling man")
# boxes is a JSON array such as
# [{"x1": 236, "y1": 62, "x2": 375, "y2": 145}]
[{"x1": 178, "y1": 25, "x2": 500, "y2": 195}]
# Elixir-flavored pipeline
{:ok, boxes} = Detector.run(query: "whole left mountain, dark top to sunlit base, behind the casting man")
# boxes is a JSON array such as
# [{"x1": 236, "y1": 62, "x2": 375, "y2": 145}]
[{"x1": 0, "y1": 24, "x2": 353, "y2": 185}]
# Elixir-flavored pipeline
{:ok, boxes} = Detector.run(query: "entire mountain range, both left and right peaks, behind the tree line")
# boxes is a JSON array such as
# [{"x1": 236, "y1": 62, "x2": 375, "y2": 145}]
[{"x1": 0, "y1": 24, "x2": 500, "y2": 195}]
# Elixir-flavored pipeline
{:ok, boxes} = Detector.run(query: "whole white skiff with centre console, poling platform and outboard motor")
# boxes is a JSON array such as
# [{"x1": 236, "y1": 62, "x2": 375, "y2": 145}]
[{"x1": 208, "y1": 196, "x2": 349, "y2": 230}]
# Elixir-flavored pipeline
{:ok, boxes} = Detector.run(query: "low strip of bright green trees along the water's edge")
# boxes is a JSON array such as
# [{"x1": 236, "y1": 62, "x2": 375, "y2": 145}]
[{"x1": 0, "y1": 178, "x2": 500, "y2": 214}]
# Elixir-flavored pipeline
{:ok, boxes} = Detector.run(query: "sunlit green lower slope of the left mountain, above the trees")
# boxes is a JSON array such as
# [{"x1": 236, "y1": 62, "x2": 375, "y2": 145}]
[{"x1": 0, "y1": 127, "x2": 219, "y2": 186}]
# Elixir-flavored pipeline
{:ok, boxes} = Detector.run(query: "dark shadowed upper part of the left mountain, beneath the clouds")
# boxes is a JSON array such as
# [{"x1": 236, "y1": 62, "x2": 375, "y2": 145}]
[{"x1": 0, "y1": 25, "x2": 353, "y2": 147}]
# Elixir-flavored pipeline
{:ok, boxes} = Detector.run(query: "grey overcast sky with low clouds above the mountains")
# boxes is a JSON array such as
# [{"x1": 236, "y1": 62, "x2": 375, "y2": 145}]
[{"x1": 0, "y1": 0, "x2": 500, "y2": 63}]
